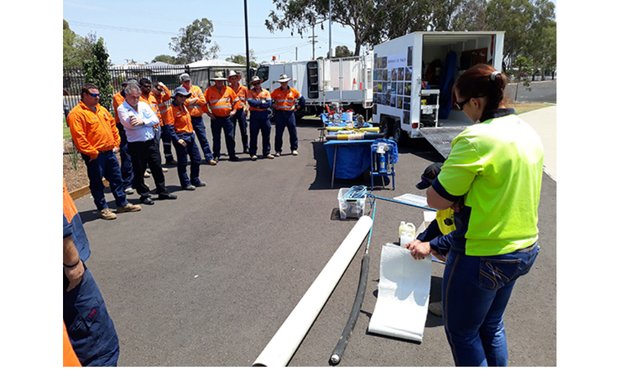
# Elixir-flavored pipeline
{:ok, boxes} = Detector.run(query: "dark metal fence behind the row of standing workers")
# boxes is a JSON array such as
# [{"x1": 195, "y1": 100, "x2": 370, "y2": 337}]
[{"x1": 63, "y1": 65, "x2": 244, "y2": 113}]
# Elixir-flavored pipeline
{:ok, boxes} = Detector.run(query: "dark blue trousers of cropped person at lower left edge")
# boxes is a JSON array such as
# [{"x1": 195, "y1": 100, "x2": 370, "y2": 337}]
[{"x1": 63, "y1": 264, "x2": 120, "y2": 367}]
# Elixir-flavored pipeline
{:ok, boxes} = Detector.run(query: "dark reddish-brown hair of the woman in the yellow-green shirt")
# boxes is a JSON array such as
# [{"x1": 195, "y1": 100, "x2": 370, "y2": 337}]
[{"x1": 453, "y1": 64, "x2": 507, "y2": 112}]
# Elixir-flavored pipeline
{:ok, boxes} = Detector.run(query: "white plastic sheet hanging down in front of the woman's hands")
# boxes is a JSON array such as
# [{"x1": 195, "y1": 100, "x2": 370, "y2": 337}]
[{"x1": 368, "y1": 244, "x2": 431, "y2": 342}]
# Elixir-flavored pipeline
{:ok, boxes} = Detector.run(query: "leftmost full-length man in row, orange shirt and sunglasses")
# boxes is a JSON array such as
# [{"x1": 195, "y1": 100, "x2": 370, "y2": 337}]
[{"x1": 67, "y1": 84, "x2": 142, "y2": 220}]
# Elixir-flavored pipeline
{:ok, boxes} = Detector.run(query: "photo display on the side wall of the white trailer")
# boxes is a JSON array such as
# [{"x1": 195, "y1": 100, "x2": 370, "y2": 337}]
[{"x1": 374, "y1": 47, "x2": 413, "y2": 124}]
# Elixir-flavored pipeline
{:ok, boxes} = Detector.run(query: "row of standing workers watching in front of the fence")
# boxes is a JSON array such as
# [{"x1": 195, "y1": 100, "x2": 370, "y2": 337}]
[{"x1": 67, "y1": 71, "x2": 305, "y2": 220}]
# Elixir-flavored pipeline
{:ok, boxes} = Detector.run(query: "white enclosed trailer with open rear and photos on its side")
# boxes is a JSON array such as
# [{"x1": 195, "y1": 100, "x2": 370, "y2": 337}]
[{"x1": 373, "y1": 31, "x2": 505, "y2": 158}]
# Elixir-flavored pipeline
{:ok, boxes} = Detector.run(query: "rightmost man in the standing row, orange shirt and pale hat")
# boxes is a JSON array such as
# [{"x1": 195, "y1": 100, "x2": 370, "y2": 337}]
[{"x1": 271, "y1": 74, "x2": 305, "y2": 157}]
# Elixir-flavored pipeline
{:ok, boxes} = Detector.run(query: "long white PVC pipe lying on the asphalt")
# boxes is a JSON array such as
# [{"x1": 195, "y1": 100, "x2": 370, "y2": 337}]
[{"x1": 254, "y1": 216, "x2": 372, "y2": 367}]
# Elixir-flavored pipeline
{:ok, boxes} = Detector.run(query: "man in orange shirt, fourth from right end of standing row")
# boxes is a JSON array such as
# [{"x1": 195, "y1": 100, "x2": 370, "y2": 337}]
[{"x1": 205, "y1": 72, "x2": 239, "y2": 161}]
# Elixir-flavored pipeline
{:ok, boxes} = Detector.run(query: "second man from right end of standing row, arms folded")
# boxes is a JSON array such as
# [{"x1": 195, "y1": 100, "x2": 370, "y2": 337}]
[{"x1": 247, "y1": 76, "x2": 274, "y2": 161}]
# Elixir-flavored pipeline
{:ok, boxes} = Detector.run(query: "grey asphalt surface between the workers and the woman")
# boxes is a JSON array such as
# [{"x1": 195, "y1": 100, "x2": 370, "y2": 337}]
[{"x1": 77, "y1": 116, "x2": 556, "y2": 367}]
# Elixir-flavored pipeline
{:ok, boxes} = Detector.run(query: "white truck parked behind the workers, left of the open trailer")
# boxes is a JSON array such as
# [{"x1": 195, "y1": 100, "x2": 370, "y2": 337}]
[{"x1": 256, "y1": 53, "x2": 373, "y2": 117}]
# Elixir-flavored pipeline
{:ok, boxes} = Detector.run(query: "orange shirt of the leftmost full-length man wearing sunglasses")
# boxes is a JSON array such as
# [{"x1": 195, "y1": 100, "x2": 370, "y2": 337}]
[{"x1": 67, "y1": 101, "x2": 120, "y2": 159}]
